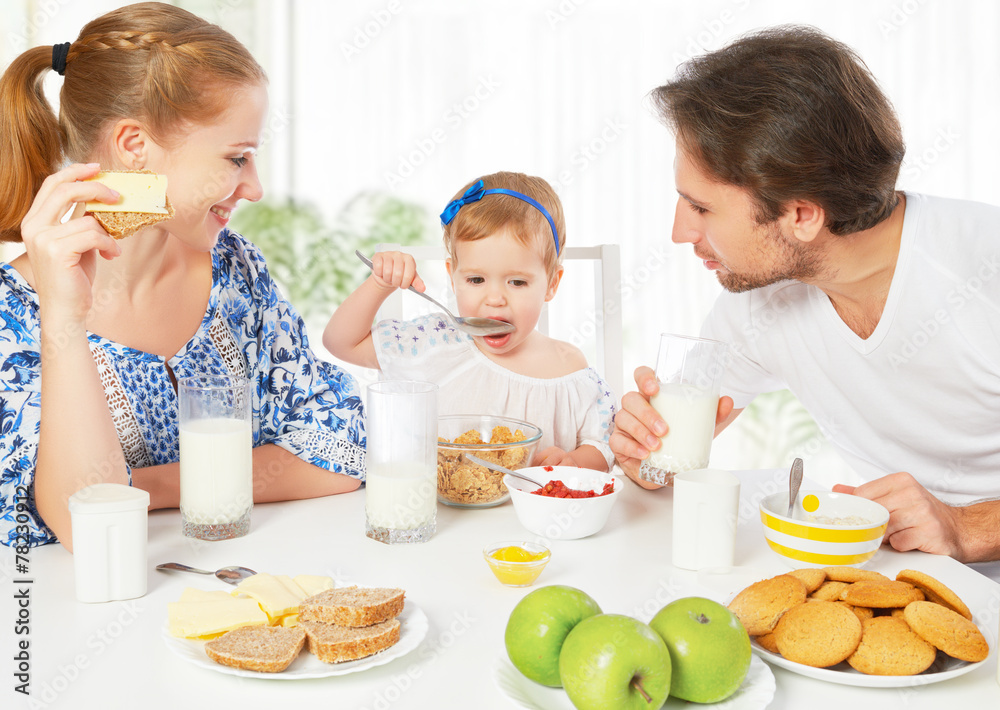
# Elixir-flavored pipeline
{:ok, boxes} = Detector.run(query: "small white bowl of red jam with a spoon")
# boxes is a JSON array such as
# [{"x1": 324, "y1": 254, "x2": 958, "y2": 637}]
[{"x1": 503, "y1": 466, "x2": 625, "y2": 540}]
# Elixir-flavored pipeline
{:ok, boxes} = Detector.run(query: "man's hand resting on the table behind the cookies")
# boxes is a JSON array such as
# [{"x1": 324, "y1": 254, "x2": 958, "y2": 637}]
[{"x1": 833, "y1": 472, "x2": 976, "y2": 562}]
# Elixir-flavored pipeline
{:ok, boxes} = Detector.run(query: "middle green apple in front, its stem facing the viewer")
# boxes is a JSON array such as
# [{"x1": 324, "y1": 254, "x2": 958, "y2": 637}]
[{"x1": 559, "y1": 614, "x2": 670, "y2": 710}]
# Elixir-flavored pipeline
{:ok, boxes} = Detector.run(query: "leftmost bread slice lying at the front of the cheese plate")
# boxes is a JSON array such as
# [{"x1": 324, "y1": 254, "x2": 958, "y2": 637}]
[{"x1": 205, "y1": 626, "x2": 306, "y2": 673}]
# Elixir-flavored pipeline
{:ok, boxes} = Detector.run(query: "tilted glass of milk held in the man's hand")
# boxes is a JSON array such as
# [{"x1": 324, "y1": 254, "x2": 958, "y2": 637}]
[{"x1": 639, "y1": 333, "x2": 729, "y2": 485}]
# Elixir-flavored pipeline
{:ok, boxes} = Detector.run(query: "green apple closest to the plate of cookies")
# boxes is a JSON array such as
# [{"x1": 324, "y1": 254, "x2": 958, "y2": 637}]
[{"x1": 649, "y1": 597, "x2": 750, "y2": 703}]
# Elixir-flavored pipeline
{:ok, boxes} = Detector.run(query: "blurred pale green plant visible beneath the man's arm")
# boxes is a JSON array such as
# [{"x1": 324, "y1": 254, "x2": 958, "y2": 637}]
[{"x1": 736, "y1": 390, "x2": 826, "y2": 468}]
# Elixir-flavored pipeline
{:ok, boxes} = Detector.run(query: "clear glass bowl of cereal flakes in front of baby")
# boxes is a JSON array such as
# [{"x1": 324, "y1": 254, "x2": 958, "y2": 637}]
[{"x1": 438, "y1": 414, "x2": 542, "y2": 508}]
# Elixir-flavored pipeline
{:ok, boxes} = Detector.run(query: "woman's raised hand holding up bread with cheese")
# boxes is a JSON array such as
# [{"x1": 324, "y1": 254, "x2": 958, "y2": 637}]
[{"x1": 21, "y1": 163, "x2": 121, "y2": 322}]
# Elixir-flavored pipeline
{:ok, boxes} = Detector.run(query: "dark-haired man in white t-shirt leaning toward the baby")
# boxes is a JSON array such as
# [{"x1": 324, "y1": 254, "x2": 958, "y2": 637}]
[{"x1": 611, "y1": 27, "x2": 1000, "y2": 562}]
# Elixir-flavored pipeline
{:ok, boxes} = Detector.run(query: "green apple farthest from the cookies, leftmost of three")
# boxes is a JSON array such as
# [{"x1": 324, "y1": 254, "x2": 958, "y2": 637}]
[{"x1": 504, "y1": 584, "x2": 601, "y2": 688}]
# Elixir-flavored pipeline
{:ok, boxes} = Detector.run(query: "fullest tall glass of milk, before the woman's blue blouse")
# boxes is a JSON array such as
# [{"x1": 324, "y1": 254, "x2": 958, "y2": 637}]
[{"x1": 177, "y1": 375, "x2": 253, "y2": 540}]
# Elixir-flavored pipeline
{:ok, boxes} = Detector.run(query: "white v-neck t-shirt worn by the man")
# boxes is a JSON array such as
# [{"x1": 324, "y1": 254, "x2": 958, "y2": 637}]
[{"x1": 702, "y1": 193, "x2": 1000, "y2": 505}]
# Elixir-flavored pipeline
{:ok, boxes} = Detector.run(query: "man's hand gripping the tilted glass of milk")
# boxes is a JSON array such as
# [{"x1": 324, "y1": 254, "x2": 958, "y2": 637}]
[{"x1": 609, "y1": 367, "x2": 733, "y2": 488}]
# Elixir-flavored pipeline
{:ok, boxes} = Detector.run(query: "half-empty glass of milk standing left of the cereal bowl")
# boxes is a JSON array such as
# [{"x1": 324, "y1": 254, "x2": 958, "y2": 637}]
[{"x1": 365, "y1": 380, "x2": 438, "y2": 544}]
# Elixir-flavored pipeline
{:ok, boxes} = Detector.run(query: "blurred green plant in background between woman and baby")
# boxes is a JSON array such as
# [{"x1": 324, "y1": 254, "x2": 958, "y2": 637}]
[{"x1": 232, "y1": 192, "x2": 432, "y2": 320}]
